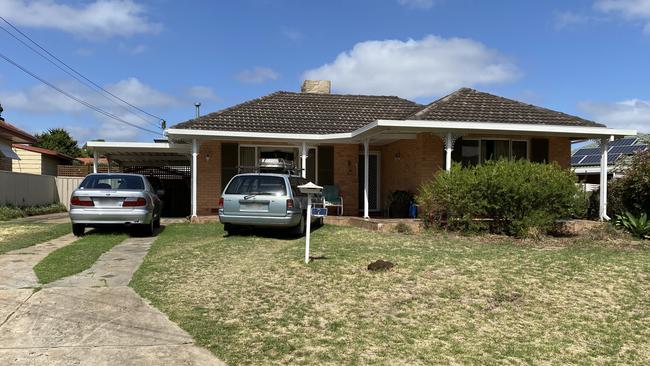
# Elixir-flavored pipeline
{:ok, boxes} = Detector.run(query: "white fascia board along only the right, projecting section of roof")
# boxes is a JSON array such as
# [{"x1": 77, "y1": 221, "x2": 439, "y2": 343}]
[{"x1": 372, "y1": 120, "x2": 637, "y2": 137}]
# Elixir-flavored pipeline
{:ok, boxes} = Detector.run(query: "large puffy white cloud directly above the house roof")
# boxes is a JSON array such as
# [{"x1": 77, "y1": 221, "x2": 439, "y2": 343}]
[{"x1": 303, "y1": 35, "x2": 521, "y2": 98}]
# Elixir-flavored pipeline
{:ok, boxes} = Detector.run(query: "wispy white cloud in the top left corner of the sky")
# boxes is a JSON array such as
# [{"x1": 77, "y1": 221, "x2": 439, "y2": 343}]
[{"x1": 0, "y1": 0, "x2": 162, "y2": 39}]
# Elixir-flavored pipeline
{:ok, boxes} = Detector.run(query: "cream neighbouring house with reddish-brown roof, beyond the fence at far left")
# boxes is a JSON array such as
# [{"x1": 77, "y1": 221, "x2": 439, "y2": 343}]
[{"x1": 12, "y1": 144, "x2": 74, "y2": 175}]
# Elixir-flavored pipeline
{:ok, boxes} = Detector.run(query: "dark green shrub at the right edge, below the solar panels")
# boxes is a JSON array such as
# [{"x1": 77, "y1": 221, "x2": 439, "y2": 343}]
[{"x1": 607, "y1": 150, "x2": 650, "y2": 217}]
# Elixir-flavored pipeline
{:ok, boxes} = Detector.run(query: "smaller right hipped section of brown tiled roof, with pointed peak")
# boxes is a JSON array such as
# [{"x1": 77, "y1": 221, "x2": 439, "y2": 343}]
[{"x1": 409, "y1": 88, "x2": 604, "y2": 127}]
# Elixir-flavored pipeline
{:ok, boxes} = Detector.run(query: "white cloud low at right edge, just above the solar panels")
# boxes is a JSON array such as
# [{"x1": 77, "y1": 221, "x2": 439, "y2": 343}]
[{"x1": 578, "y1": 99, "x2": 650, "y2": 132}]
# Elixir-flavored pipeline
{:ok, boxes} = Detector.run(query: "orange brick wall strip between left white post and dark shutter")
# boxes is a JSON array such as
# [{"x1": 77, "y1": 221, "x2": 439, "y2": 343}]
[{"x1": 196, "y1": 141, "x2": 221, "y2": 216}]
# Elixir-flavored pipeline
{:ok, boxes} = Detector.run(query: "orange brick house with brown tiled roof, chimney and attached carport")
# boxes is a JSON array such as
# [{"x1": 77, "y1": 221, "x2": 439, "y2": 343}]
[{"x1": 86, "y1": 80, "x2": 636, "y2": 218}]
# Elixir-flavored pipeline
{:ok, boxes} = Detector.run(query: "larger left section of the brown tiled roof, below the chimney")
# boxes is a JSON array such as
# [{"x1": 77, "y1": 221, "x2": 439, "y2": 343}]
[{"x1": 173, "y1": 91, "x2": 422, "y2": 134}]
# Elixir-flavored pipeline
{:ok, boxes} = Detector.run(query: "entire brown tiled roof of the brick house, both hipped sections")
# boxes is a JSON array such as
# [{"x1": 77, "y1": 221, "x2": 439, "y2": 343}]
[{"x1": 173, "y1": 88, "x2": 603, "y2": 134}]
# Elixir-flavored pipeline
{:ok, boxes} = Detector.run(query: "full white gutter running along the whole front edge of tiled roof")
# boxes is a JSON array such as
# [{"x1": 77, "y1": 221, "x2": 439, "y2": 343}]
[{"x1": 165, "y1": 120, "x2": 637, "y2": 141}]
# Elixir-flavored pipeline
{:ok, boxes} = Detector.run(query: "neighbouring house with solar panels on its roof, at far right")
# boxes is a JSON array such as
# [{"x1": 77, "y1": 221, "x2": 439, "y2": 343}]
[{"x1": 571, "y1": 136, "x2": 649, "y2": 191}]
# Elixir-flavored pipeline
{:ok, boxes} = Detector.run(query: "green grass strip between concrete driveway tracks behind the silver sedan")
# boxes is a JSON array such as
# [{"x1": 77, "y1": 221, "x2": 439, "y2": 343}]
[{"x1": 34, "y1": 232, "x2": 128, "y2": 284}]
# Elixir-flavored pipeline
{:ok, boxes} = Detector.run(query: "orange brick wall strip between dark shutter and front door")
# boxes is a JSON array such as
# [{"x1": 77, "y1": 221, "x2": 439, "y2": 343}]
[{"x1": 334, "y1": 144, "x2": 359, "y2": 216}]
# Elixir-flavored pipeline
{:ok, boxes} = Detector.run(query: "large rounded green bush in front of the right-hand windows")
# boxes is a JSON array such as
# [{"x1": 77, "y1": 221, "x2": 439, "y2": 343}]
[{"x1": 417, "y1": 159, "x2": 587, "y2": 236}]
